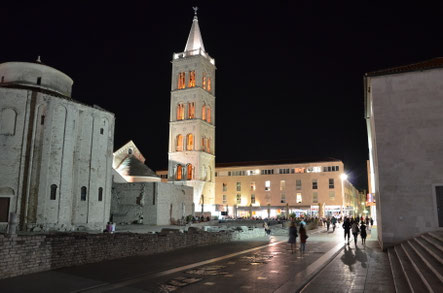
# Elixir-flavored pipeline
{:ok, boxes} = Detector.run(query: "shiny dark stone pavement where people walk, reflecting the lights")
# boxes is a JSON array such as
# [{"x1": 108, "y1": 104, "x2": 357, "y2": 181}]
[{"x1": 0, "y1": 224, "x2": 394, "y2": 293}]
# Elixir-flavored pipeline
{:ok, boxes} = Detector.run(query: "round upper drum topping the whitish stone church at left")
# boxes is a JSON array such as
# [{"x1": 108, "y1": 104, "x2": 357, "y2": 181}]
[{"x1": 0, "y1": 62, "x2": 74, "y2": 98}]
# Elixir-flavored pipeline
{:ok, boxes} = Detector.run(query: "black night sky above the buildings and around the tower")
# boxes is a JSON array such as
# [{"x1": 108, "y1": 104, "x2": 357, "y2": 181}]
[{"x1": 0, "y1": 0, "x2": 443, "y2": 188}]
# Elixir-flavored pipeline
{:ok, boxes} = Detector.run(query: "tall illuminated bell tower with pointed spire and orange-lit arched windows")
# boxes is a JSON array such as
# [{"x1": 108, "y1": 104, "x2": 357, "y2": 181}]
[{"x1": 168, "y1": 8, "x2": 215, "y2": 212}]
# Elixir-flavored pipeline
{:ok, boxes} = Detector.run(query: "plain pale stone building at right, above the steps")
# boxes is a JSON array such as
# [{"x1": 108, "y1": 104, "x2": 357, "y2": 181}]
[{"x1": 365, "y1": 58, "x2": 443, "y2": 249}]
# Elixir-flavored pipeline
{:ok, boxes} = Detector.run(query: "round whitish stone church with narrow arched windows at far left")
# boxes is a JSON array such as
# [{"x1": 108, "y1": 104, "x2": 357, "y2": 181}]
[{"x1": 0, "y1": 62, "x2": 115, "y2": 231}]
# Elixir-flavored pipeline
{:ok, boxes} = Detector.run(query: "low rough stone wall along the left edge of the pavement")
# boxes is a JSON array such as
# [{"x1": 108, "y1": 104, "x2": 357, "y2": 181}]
[{"x1": 0, "y1": 228, "x2": 264, "y2": 279}]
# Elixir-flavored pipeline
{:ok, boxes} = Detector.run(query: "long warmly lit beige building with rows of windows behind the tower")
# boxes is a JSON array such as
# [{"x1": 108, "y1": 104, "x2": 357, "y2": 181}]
[{"x1": 157, "y1": 160, "x2": 360, "y2": 218}]
